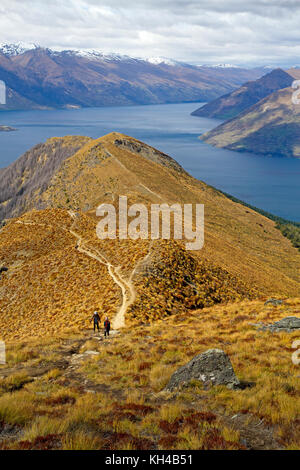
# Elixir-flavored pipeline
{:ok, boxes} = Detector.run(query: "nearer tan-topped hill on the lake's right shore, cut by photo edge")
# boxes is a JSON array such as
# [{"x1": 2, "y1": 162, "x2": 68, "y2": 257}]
[{"x1": 201, "y1": 88, "x2": 300, "y2": 158}]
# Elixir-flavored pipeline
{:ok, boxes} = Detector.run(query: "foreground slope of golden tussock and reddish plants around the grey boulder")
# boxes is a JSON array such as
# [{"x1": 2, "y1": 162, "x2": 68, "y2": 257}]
[{"x1": 0, "y1": 299, "x2": 300, "y2": 450}]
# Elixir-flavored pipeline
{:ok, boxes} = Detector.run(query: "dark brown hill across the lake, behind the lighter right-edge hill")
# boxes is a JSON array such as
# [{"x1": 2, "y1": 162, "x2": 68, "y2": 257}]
[{"x1": 192, "y1": 69, "x2": 294, "y2": 120}]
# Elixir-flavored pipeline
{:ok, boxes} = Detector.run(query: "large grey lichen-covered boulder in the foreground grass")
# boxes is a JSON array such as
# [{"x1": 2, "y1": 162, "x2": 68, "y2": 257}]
[{"x1": 166, "y1": 349, "x2": 240, "y2": 391}]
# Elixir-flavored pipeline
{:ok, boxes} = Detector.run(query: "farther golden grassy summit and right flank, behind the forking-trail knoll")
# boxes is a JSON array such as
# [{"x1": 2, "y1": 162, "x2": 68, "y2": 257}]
[{"x1": 28, "y1": 133, "x2": 300, "y2": 295}]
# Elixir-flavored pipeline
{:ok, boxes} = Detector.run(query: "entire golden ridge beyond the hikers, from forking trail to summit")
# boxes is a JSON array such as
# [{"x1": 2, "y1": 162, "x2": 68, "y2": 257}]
[{"x1": 0, "y1": 133, "x2": 300, "y2": 339}]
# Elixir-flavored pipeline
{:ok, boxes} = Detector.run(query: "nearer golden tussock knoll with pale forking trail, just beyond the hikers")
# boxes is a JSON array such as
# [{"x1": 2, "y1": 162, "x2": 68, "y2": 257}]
[{"x1": 0, "y1": 209, "x2": 256, "y2": 339}]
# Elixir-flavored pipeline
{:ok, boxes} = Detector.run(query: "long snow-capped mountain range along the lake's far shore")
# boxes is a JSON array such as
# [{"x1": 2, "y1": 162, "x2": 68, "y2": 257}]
[{"x1": 0, "y1": 44, "x2": 263, "y2": 110}]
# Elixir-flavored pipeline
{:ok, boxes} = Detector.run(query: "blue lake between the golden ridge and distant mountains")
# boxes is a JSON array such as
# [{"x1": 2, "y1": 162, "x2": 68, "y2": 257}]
[{"x1": 0, "y1": 103, "x2": 300, "y2": 222}]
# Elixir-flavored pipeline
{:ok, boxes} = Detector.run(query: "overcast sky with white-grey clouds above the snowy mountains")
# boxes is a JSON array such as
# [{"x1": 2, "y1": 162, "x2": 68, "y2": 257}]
[{"x1": 0, "y1": 0, "x2": 300, "y2": 66}]
